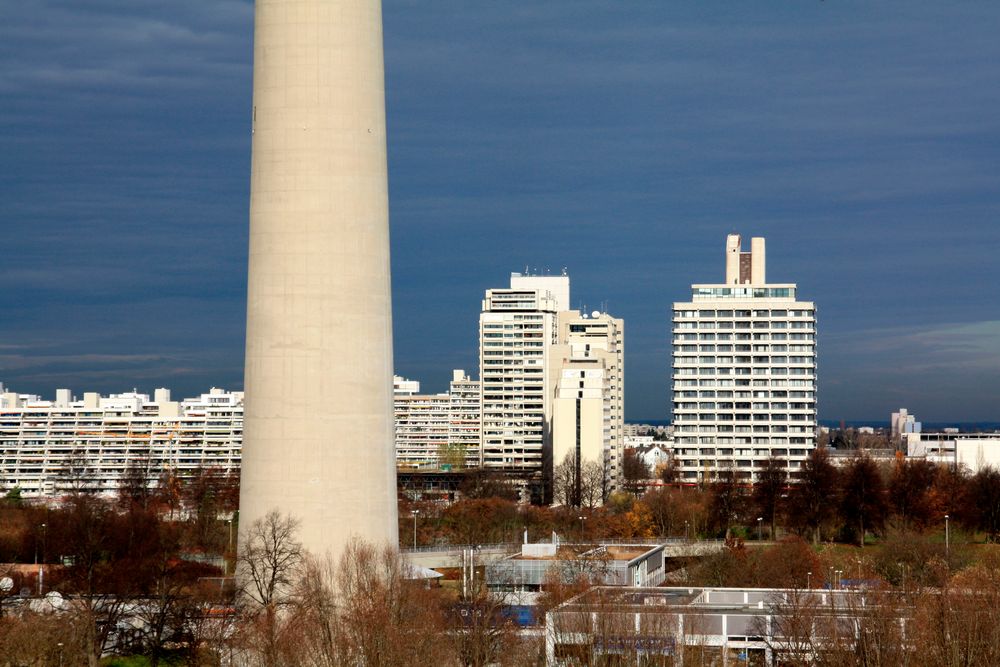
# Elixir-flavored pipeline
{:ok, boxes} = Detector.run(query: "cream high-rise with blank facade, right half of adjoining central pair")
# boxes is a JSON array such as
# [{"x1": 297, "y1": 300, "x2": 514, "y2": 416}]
[{"x1": 552, "y1": 310, "x2": 625, "y2": 493}]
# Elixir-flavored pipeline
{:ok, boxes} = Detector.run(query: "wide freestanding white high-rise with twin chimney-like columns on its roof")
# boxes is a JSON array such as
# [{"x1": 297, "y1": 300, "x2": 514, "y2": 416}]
[{"x1": 672, "y1": 234, "x2": 817, "y2": 482}]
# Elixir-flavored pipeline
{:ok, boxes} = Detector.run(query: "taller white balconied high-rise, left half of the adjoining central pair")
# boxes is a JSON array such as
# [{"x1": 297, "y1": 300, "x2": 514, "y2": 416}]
[{"x1": 479, "y1": 273, "x2": 569, "y2": 488}]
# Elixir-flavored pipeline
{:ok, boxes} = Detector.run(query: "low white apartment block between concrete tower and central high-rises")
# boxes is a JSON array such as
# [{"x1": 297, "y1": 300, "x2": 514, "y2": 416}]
[{"x1": 394, "y1": 370, "x2": 480, "y2": 470}]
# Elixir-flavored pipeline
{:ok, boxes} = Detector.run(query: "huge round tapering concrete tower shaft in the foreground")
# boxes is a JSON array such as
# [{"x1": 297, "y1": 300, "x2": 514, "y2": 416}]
[{"x1": 240, "y1": 0, "x2": 397, "y2": 555}]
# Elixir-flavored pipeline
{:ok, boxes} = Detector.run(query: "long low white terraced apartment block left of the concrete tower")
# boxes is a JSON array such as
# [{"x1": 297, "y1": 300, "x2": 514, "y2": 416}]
[{"x1": 0, "y1": 388, "x2": 243, "y2": 498}]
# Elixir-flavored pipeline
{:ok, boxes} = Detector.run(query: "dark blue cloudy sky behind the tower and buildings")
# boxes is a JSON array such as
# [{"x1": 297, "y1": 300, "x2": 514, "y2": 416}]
[{"x1": 0, "y1": 0, "x2": 1000, "y2": 421}]
